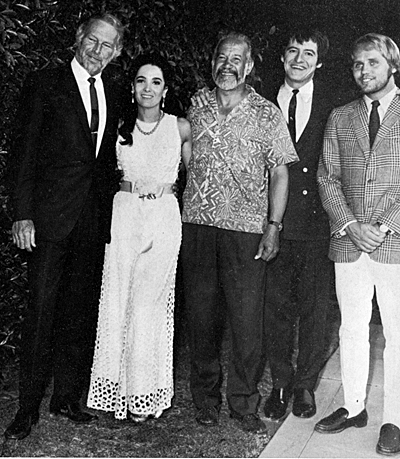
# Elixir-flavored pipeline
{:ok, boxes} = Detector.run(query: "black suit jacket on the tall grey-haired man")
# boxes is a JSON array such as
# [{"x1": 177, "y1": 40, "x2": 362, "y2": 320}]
[{"x1": 10, "y1": 64, "x2": 126, "y2": 241}]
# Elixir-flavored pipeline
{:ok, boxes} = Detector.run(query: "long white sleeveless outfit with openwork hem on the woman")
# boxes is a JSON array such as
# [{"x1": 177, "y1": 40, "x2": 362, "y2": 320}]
[{"x1": 88, "y1": 114, "x2": 181, "y2": 419}]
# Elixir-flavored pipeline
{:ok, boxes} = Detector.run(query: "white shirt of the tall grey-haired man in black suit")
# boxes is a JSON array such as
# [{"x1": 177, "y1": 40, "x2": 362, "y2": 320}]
[{"x1": 71, "y1": 57, "x2": 107, "y2": 156}]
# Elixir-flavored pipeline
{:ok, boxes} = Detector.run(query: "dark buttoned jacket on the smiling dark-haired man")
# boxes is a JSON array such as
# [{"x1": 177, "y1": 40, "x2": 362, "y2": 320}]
[{"x1": 267, "y1": 81, "x2": 334, "y2": 240}]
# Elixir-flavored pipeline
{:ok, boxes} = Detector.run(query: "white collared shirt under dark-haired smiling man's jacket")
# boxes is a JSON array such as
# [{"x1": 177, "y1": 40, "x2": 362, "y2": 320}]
[{"x1": 277, "y1": 80, "x2": 314, "y2": 142}]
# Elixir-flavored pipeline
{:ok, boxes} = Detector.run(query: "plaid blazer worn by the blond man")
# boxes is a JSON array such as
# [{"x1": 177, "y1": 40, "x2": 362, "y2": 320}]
[{"x1": 317, "y1": 96, "x2": 400, "y2": 263}]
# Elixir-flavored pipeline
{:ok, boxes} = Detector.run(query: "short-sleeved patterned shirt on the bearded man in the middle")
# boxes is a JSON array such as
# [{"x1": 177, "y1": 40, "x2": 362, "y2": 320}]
[{"x1": 182, "y1": 86, "x2": 298, "y2": 233}]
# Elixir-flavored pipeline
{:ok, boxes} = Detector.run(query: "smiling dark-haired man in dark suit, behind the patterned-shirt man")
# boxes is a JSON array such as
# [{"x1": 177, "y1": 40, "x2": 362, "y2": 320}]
[{"x1": 264, "y1": 30, "x2": 333, "y2": 420}]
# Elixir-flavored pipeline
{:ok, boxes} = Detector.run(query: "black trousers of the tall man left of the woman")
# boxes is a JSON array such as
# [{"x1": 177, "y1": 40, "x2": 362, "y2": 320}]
[{"x1": 20, "y1": 192, "x2": 104, "y2": 413}]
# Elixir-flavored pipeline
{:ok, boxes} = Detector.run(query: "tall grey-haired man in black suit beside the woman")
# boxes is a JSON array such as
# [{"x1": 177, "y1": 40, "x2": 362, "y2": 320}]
[{"x1": 5, "y1": 14, "x2": 129, "y2": 440}]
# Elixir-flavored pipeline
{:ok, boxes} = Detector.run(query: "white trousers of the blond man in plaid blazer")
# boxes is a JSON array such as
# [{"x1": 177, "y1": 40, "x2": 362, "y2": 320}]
[{"x1": 335, "y1": 253, "x2": 400, "y2": 427}]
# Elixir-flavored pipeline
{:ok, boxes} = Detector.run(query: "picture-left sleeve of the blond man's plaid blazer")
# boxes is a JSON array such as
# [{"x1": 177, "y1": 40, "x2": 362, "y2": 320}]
[{"x1": 317, "y1": 110, "x2": 357, "y2": 237}]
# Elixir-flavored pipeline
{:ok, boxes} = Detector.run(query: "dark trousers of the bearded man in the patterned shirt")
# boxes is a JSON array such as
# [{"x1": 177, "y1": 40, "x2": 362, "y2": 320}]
[{"x1": 181, "y1": 223, "x2": 265, "y2": 415}]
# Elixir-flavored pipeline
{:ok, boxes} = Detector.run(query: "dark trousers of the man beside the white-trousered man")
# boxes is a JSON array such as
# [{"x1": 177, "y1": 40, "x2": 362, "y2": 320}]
[{"x1": 265, "y1": 239, "x2": 333, "y2": 390}]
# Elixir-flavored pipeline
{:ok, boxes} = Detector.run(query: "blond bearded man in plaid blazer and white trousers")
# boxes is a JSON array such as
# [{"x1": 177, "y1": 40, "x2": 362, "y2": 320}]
[{"x1": 315, "y1": 33, "x2": 400, "y2": 455}]
